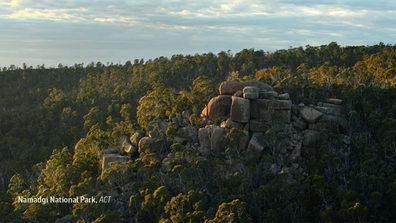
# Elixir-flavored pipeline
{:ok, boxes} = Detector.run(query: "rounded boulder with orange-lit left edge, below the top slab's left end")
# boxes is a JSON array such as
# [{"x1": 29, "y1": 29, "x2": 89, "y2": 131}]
[{"x1": 202, "y1": 95, "x2": 232, "y2": 121}]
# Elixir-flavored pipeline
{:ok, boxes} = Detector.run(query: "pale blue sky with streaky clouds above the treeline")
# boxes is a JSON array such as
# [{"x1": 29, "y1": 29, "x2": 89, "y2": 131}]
[{"x1": 0, "y1": 0, "x2": 396, "y2": 67}]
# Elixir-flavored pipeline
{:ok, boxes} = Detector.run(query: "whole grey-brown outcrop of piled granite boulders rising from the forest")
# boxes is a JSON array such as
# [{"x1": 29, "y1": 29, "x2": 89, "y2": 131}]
[{"x1": 101, "y1": 81, "x2": 350, "y2": 185}]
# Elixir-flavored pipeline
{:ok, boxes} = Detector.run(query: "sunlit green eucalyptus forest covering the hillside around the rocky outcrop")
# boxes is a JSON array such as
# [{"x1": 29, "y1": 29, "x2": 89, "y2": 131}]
[{"x1": 0, "y1": 42, "x2": 396, "y2": 223}]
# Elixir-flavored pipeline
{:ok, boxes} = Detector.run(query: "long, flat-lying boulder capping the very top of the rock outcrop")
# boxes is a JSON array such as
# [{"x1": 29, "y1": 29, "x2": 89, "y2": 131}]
[{"x1": 219, "y1": 81, "x2": 274, "y2": 95}]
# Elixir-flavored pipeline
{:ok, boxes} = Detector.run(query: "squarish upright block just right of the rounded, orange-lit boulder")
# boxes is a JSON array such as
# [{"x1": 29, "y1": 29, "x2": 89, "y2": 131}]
[{"x1": 231, "y1": 97, "x2": 250, "y2": 123}]
